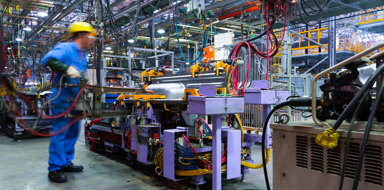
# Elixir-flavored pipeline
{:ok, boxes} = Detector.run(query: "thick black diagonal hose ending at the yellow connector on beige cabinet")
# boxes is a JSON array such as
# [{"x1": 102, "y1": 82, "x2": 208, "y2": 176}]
[{"x1": 332, "y1": 65, "x2": 384, "y2": 130}]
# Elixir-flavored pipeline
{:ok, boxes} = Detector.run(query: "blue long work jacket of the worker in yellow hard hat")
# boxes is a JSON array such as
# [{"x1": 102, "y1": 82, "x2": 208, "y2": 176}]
[{"x1": 42, "y1": 42, "x2": 88, "y2": 109}]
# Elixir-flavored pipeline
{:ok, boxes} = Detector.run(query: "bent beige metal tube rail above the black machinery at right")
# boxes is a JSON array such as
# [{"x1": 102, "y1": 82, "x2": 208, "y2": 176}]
[{"x1": 312, "y1": 42, "x2": 384, "y2": 127}]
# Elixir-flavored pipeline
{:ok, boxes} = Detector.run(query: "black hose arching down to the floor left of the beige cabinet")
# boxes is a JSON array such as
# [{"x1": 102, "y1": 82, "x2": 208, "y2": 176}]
[{"x1": 261, "y1": 97, "x2": 320, "y2": 190}]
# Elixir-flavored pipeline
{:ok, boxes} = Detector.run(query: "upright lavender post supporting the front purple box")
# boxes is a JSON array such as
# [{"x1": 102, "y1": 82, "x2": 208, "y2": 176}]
[{"x1": 212, "y1": 115, "x2": 221, "y2": 190}]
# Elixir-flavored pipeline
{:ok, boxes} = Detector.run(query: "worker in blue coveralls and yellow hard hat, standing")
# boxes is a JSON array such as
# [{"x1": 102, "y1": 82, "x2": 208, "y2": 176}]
[{"x1": 42, "y1": 22, "x2": 93, "y2": 183}]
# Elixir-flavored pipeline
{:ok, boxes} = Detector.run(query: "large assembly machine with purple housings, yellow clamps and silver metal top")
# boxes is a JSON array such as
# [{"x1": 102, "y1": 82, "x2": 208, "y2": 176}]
[{"x1": 84, "y1": 58, "x2": 289, "y2": 189}]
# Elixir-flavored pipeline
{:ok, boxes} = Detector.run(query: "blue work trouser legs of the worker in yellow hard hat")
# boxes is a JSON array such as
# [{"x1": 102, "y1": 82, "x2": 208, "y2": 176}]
[{"x1": 48, "y1": 109, "x2": 80, "y2": 172}]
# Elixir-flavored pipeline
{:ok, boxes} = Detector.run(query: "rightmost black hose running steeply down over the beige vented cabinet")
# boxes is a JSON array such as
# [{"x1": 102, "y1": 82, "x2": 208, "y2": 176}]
[{"x1": 352, "y1": 80, "x2": 384, "y2": 190}]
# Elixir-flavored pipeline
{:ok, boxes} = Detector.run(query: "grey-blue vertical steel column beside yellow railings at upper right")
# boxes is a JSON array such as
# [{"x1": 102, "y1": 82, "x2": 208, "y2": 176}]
[{"x1": 328, "y1": 17, "x2": 336, "y2": 68}]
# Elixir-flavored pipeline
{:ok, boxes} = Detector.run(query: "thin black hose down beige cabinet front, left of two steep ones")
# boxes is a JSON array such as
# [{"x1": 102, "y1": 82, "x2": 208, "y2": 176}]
[{"x1": 339, "y1": 88, "x2": 370, "y2": 190}]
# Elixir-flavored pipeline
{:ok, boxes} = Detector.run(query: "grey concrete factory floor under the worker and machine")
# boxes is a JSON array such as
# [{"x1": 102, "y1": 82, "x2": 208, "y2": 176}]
[{"x1": 0, "y1": 133, "x2": 272, "y2": 190}]
